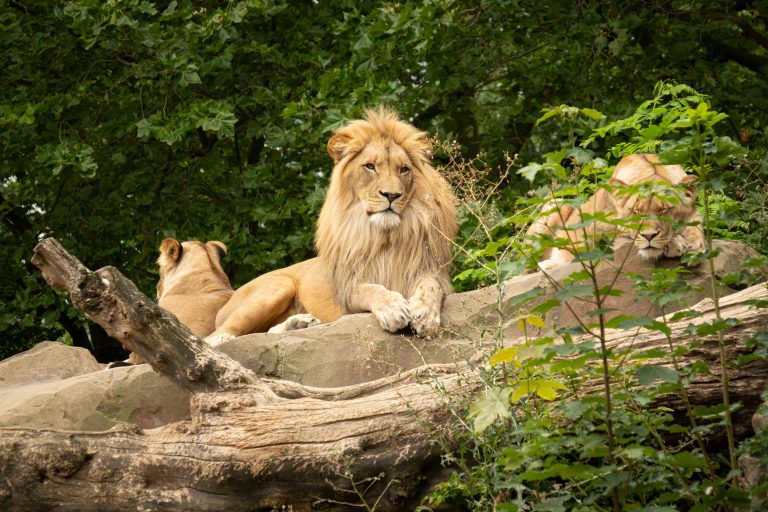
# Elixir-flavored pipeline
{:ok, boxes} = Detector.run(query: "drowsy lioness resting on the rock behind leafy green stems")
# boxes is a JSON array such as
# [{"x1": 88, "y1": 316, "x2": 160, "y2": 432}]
[{"x1": 526, "y1": 154, "x2": 704, "y2": 269}]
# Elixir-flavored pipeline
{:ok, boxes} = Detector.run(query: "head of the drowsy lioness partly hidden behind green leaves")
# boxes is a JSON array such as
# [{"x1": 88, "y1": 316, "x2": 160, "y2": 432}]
[{"x1": 610, "y1": 174, "x2": 698, "y2": 261}]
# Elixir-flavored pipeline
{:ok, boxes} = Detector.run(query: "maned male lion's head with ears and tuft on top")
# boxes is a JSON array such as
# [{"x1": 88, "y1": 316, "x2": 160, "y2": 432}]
[{"x1": 320, "y1": 109, "x2": 434, "y2": 230}]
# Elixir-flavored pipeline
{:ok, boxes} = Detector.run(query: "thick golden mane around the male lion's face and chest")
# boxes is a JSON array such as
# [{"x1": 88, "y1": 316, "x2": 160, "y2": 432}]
[{"x1": 315, "y1": 108, "x2": 457, "y2": 311}]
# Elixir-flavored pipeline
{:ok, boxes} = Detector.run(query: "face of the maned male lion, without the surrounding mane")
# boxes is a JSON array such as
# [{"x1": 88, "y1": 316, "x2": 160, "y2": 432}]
[{"x1": 345, "y1": 141, "x2": 414, "y2": 230}]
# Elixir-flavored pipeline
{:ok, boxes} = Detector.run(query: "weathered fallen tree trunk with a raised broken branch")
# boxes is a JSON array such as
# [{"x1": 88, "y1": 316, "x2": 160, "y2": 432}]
[{"x1": 0, "y1": 239, "x2": 768, "y2": 511}]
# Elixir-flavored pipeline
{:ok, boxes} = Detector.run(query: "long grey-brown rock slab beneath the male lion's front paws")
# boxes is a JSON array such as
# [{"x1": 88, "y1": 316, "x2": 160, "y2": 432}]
[{"x1": 219, "y1": 241, "x2": 757, "y2": 387}]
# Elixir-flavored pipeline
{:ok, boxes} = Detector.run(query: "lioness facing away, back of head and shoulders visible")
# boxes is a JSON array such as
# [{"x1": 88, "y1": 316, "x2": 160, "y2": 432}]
[{"x1": 117, "y1": 238, "x2": 233, "y2": 366}]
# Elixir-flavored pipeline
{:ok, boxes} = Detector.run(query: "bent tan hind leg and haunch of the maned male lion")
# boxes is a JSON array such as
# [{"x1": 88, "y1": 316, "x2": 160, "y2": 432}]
[{"x1": 205, "y1": 274, "x2": 296, "y2": 346}]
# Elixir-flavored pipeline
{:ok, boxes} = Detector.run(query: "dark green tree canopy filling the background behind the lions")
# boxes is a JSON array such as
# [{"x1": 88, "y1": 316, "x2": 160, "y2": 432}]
[{"x1": 0, "y1": 0, "x2": 768, "y2": 357}]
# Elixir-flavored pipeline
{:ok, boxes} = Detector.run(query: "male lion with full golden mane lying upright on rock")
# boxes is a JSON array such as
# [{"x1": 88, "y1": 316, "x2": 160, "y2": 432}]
[{"x1": 208, "y1": 108, "x2": 457, "y2": 344}]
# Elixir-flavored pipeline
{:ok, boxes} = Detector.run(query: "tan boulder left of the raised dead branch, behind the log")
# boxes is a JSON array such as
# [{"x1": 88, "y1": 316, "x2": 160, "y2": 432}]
[{"x1": 0, "y1": 341, "x2": 189, "y2": 431}]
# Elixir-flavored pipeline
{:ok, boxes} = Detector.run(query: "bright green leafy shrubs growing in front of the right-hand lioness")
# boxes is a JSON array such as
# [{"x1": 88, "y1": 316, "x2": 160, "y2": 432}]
[{"x1": 422, "y1": 83, "x2": 768, "y2": 511}]
